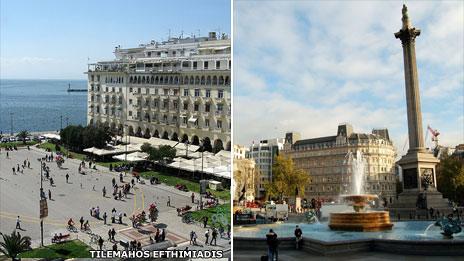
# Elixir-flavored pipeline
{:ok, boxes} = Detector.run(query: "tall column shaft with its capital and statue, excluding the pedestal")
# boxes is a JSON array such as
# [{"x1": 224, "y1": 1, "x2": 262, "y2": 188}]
[{"x1": 395, "y1": 5, "x2": 425, "y2": 151}]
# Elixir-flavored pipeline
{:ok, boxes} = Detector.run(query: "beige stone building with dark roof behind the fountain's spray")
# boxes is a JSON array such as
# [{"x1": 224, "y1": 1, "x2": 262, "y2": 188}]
[{"x1": 283, "y1": 124, "x2": 397, "y2": 204}]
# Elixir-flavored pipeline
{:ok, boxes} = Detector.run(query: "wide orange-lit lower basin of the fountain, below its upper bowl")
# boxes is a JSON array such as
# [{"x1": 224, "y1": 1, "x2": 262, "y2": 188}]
[{"x1": 329, "y1": 211, "x2": 393, "y2": 231}]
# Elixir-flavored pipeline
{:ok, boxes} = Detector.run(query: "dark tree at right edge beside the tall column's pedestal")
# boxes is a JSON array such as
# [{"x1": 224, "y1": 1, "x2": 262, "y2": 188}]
[{"x1": 437, "y1": 156, "x2": 464, "y2": 205}]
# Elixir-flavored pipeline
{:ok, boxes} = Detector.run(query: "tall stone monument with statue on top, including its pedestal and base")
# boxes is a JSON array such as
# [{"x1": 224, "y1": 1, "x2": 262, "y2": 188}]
[{"x1": 392, "y1": 5, "x2": 449, "y2": 210}]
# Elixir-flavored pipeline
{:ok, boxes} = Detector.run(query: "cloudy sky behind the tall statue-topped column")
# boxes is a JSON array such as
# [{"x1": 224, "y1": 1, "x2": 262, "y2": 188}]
[{"x1": 233, "y1": 0, "x2": 464, "y2": 155}]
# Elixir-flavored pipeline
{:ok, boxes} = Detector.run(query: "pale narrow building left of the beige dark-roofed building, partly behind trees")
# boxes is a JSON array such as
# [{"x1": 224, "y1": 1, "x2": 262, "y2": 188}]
[{"x1": 246, "y1": 138, "x2": 284, "y2": 198}]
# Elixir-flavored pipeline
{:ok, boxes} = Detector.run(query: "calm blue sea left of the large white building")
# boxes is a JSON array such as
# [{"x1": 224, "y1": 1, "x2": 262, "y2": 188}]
[{"x1": 0, "y1": 79, "x2": 87, "y2": 133}]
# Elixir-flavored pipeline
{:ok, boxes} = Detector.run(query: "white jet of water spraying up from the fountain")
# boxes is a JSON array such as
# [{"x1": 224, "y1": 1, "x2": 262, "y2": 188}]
[{"x1": 345, "y1": 150, "x2": 366, "y2": 195}]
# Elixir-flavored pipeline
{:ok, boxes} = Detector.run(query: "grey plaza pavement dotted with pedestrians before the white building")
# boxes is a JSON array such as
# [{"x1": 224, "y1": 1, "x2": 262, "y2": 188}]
[{"x1": 0, "y1": 144, "x2": 230, "y2": 251}]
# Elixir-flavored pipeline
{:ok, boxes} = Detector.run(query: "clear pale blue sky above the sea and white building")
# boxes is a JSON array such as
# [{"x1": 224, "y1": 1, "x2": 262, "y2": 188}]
[{"x1": 0, "y1": 0, "x2": 231, "y2": 79}]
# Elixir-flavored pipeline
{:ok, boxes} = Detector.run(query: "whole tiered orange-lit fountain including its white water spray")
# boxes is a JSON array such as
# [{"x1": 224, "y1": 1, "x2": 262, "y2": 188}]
[{"x1": 329, "y1": 151, "x2": 393, "y2": 231}]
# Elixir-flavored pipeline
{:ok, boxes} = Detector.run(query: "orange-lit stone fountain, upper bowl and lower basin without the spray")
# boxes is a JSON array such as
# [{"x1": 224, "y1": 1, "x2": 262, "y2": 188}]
[{"x1": 329, "y1": 194, "x2": 393, "y2": 231}]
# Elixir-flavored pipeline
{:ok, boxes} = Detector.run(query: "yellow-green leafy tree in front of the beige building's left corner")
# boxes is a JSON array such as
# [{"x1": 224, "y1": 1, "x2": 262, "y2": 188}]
[{"x1": 264, "y1": 155, "x2": 310, "y2": 199}]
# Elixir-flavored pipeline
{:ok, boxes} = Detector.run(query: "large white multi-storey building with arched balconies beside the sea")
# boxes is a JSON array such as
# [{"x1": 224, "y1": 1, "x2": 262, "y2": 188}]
[{"x1": 87, "y1": 32, "x2": 232, "y2": 150}]
